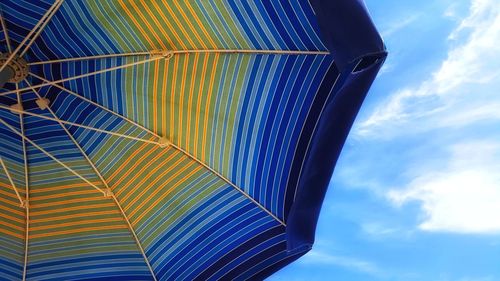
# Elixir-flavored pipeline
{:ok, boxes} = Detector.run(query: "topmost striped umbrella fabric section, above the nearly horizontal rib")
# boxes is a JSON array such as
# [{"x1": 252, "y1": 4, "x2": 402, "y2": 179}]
[{"x1": 11, "y1": 0, "x2": 325, "y2": 59}]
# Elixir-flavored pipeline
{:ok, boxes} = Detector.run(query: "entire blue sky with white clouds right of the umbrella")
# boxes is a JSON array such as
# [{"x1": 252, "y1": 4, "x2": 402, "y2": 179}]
[{"x1": 269, "y1": 0, "x2": 500, "y2": 281}]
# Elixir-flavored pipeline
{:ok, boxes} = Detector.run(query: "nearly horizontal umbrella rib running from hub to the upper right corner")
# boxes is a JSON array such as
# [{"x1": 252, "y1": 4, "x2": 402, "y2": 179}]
[{"x1": 28, "y1": 49, "x2": 330, "y2": 66}]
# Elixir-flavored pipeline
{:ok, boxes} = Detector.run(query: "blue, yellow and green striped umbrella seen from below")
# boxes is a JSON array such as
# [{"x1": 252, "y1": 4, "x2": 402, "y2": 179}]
[{"x1": 0, "y1": 0, "x2": 386, "y2": 280}]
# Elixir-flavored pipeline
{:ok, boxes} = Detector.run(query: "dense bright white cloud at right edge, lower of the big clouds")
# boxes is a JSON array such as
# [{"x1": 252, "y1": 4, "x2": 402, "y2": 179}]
[{"x1": 388, "y1": 141, "x2": 500, "y2": 234}]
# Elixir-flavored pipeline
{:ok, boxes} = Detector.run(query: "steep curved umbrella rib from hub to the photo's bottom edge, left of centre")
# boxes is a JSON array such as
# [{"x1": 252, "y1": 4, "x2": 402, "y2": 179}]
[{"x1": 24, "y1": 79, "x2": 157, "y2": 281}]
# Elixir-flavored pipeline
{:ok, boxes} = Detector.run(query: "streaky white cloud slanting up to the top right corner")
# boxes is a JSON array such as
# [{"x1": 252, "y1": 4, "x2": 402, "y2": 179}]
[{"x1": 355, "y1": 0, "x2": 500, "y2": 137}]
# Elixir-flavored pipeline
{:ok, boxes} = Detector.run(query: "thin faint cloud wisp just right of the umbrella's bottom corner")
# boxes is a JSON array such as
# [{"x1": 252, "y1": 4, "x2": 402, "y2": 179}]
[{"x1": 300, "y1": 249, "x2": 383, "y2": 276}]
